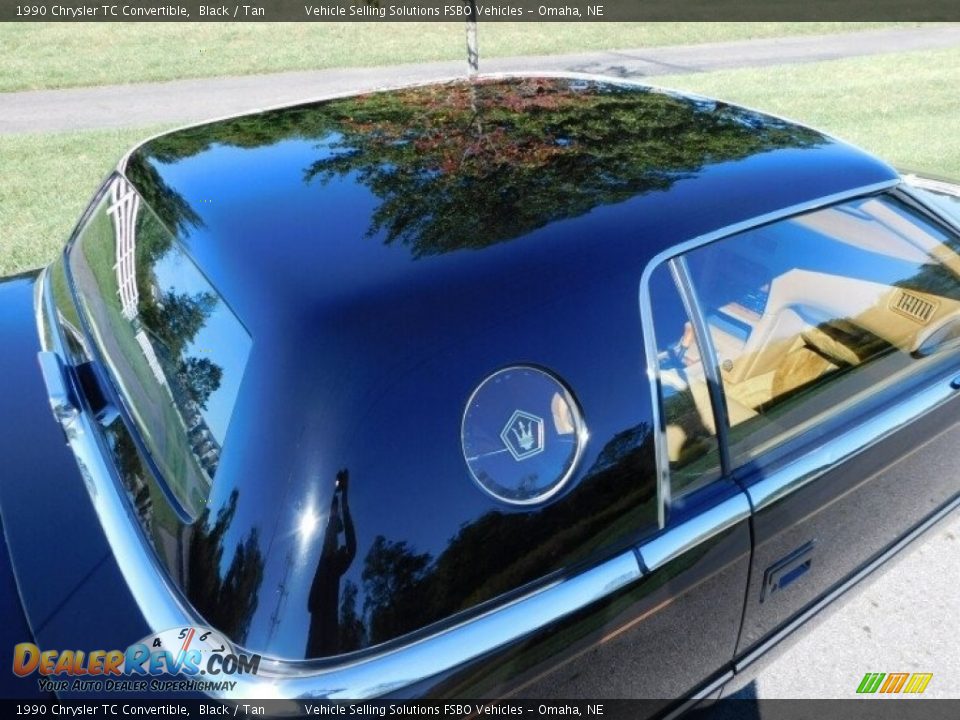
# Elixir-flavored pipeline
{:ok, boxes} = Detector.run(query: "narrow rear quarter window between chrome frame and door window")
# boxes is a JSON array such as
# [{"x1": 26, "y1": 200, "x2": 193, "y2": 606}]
[{"x1": 650, "y1": 264, "x2": 720, "y2": 497}]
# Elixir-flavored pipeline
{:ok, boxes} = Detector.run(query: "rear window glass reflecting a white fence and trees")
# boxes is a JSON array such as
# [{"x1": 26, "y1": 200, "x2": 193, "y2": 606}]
[{"x1": 68, "y1": 177, "x2": 251, "y2": 517}]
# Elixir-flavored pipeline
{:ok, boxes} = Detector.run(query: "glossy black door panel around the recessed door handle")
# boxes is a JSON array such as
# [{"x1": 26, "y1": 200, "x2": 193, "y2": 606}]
[{"x1": 737, "y1": 368, "x2": 960, "y2": 655}]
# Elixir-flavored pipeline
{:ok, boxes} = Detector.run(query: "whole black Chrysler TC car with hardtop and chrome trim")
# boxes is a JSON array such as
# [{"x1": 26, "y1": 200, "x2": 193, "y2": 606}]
[{"x1": 0, "y1": 76, "x2": 960, "y2": 710}]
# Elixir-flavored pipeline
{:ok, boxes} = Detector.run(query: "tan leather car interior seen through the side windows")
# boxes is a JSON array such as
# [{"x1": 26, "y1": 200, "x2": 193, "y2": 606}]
[{"x1": 661, "y1": 270, "x2": 960, "y2": 452}]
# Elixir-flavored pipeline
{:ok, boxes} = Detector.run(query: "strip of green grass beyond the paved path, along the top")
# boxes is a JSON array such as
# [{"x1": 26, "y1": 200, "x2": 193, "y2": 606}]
[{"x1": 0, "y1": 22, "x2": 919, "y2": 92}]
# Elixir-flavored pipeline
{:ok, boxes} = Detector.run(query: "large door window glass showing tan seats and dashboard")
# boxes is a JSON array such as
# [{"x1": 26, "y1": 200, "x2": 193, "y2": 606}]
[{"x1": 687, "y1": 196, "x2": 960, "y2": 464}]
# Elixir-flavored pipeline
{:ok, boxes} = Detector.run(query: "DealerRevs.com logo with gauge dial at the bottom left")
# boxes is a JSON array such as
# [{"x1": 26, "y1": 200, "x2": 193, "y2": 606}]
[{"x1": 13, "y1": 627, "x2": 260, "y2": 692}]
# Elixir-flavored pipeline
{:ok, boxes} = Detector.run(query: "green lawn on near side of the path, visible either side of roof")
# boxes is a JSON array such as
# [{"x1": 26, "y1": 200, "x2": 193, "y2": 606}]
[{"x1": 0, "y1": 48, "x2": 960, "y2": 275}]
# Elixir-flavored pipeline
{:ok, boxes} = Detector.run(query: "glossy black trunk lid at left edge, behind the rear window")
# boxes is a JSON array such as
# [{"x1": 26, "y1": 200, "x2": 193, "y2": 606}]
[{"x1": 0, "y1": 273, "x2": 149, "y2": 697}]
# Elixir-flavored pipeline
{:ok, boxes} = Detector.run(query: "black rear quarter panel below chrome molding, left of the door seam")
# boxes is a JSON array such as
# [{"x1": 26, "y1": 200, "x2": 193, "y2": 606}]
[{"x1": 396, "y1": 510, "x2": 750, "y2": 704}]
